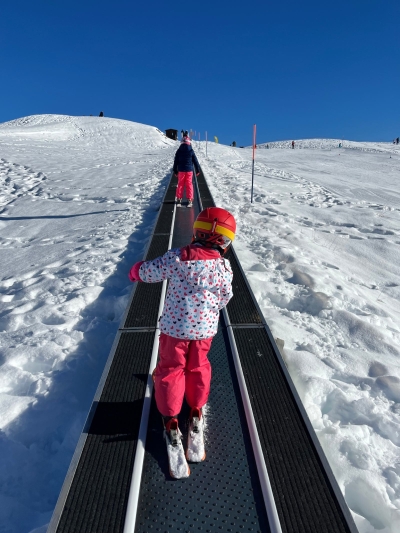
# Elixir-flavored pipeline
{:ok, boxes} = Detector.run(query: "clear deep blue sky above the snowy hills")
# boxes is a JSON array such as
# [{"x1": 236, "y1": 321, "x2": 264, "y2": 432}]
[{"x1": 0, "y1": 0, "x2": 400, "y2": 145}]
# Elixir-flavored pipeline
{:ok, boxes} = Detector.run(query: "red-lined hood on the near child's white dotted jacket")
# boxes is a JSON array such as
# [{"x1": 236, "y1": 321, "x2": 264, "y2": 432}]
[{"x1": 178, "y1": 245, "x2": 230, "y2": 289}]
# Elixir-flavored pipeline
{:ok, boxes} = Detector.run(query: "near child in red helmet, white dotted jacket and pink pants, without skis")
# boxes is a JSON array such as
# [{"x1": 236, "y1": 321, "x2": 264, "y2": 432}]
[{"x1": 129, "y1": 207, "x2": 236, "y2": 474}]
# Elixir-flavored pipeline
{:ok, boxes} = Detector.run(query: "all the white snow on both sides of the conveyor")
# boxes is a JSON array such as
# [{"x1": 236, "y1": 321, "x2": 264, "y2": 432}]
[{"x1": 0, "y1": 115, "x2": 400, "y2": 533}]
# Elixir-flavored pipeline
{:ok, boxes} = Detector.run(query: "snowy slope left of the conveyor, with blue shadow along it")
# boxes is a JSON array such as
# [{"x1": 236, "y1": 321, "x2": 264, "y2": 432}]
[{"x1": 0, "y1": 115, "x2": 176, "y2": 533}]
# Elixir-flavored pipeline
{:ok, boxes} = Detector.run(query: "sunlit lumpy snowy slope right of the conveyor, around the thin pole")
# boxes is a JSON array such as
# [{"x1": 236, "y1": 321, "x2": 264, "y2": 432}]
[{"x1": 198, "y1": 140, "x2": 400, "y2": 533}]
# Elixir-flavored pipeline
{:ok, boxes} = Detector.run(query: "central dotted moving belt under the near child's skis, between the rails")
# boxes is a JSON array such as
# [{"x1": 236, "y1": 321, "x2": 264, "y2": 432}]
[{"x1": 135, "y1": 184, "x2": 269, "y2": 533}]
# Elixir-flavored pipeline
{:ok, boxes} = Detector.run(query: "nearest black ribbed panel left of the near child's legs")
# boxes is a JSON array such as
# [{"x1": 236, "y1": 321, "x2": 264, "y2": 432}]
[{"x1": 57, "y1": 332, "x2": 154, "y2": 533}]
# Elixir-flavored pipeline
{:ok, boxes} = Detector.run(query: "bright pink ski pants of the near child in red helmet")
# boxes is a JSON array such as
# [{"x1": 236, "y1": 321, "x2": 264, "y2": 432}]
[{"x1": 153, "y1": 333, "x2": 212, "y2": 416}]
